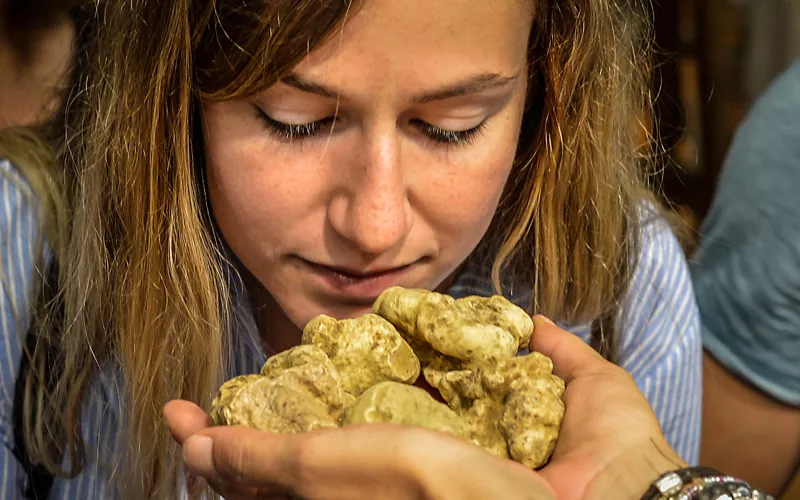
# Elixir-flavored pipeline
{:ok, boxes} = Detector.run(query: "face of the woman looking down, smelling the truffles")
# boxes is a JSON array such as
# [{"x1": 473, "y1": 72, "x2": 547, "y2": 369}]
[{"x1": 203, "y1": 0, "x2": 533, "y2": 328}]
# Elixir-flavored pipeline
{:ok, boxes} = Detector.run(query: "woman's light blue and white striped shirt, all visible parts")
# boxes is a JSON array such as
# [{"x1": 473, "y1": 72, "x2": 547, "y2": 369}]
[{"x1": 0, "y1": 160, "x2": 702, "y2": 500}]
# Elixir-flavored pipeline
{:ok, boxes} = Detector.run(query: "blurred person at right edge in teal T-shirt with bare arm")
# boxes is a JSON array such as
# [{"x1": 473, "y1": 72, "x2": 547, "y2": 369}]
[{"x1": 691, "y1": 61, "x2": 800, "y2": 494}]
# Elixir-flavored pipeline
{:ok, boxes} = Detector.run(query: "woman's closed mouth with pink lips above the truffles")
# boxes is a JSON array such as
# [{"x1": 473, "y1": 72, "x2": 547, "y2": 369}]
[{"x1": 303, "y1": 260, "x2": 415, "y2": 305}]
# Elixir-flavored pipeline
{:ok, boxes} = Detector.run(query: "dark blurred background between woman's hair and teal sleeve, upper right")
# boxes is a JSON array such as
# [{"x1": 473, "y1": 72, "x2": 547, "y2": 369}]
[{"x1": 653, "y1": 0, "x2": 800, "y2": 254}]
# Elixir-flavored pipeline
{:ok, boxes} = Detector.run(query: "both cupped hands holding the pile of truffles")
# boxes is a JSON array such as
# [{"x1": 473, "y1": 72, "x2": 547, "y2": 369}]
[{"x1": 164, "y1": 317, "x2": 685, "y2": 500}]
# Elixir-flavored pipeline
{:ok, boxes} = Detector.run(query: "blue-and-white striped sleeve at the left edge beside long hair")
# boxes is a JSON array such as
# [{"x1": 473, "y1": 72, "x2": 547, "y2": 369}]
[{"x1": 0, "y1": 159, "x2": 43, "y2": 498}]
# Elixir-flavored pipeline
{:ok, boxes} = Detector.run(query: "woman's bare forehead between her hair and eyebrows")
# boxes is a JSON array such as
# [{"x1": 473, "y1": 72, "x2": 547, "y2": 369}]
[{"x1": 295, "y1": 0, "x2": 533, "y2": 95}]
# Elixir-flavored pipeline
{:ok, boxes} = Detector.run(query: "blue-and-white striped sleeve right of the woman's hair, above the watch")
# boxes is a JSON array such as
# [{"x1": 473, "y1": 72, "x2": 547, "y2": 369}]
[{"x1": 620, "y1": 218, "x2": 703, "y2": 464}]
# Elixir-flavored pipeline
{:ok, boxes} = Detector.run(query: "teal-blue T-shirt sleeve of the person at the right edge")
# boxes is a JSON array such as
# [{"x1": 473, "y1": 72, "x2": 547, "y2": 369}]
[{"x1": 692, "y1": 62, "x2": 800, "y2": 406}]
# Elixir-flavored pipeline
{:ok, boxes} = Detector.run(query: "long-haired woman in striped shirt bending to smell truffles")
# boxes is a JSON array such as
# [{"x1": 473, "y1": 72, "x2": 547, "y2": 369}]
[{"x1": 0, "y1": 0, "x2": 701, "y2": 498}]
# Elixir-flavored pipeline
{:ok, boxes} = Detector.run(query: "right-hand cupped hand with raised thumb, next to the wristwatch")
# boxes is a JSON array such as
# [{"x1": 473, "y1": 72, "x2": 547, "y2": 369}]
[{"x1": 531, "y1": 316, "x2": 686, "y2": 500}]
